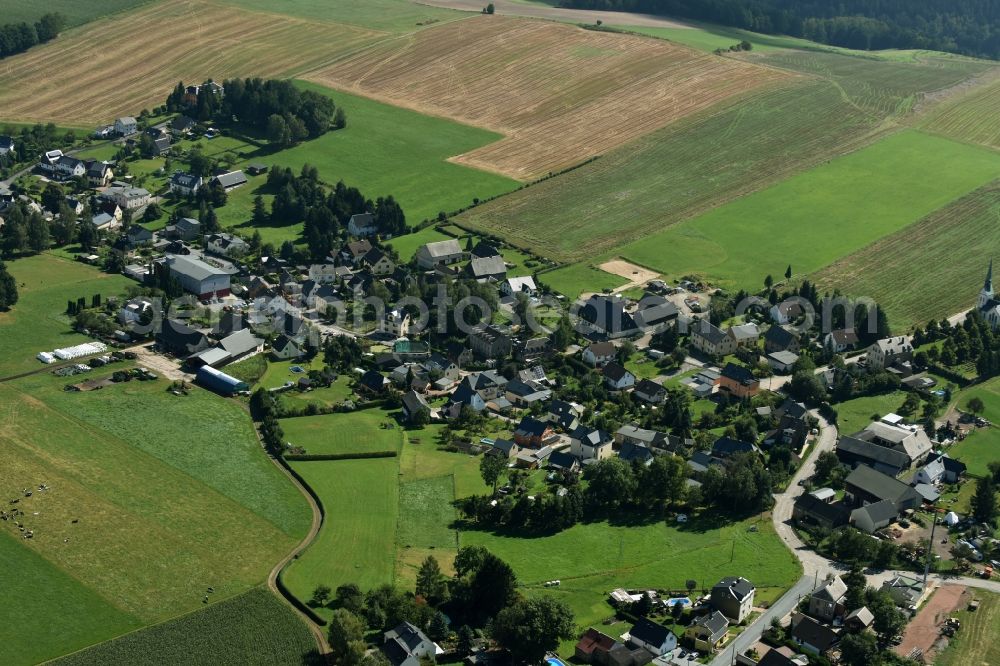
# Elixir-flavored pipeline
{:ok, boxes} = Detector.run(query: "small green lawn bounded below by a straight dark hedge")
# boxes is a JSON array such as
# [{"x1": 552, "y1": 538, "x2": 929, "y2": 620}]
[{"x1": 281, "y1": 409, "x2": 403, "y2": 454}]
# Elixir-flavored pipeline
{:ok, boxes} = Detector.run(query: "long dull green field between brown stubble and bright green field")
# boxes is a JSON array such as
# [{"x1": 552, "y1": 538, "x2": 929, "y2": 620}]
[{"x1": 457, "y1": 80, "x2": 880, "y2": 262}]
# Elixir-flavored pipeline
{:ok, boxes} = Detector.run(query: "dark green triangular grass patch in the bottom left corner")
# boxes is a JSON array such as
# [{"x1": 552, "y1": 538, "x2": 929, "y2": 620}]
[{"x1": 0, "y1": 530, "x2": 142, "y2": 666}]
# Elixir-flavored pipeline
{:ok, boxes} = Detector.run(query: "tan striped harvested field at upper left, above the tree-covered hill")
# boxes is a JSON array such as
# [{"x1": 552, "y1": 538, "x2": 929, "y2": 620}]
[{"x1": 0, "y1": 0, "x2": 382, "y2": 124}]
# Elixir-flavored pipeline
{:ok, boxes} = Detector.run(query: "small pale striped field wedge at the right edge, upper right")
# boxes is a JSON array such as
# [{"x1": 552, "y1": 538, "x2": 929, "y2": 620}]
[{"x1": 920, "y1": 72, "x2": 1000, "y2": 148}]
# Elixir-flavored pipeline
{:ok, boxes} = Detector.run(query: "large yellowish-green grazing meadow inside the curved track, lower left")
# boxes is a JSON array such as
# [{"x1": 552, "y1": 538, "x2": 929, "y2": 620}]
[{"x1": 0, "y1": 373, "x2": 309, "y2": 658}]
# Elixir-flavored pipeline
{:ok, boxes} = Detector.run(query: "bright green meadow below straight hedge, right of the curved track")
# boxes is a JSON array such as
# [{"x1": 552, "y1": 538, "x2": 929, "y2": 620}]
[{"x1": 283, "y1": 458, "x2": 399, "y2": 617}]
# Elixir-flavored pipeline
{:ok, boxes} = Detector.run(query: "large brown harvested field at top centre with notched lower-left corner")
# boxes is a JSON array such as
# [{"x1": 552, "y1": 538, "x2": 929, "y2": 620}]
[{"x1": 305, "y1": 16, "x2": 793, "y2": 180}]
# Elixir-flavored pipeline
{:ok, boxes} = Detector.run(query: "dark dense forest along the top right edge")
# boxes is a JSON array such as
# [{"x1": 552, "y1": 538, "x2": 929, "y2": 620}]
[{"x1": 563, "y1": 0, "x2": 1000, "y2": 59}]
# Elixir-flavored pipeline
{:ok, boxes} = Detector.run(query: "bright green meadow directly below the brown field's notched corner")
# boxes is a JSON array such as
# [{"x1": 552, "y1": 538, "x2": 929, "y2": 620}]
[{"x1": 210, "y1": 81, "x2": 519, "y2": 242}]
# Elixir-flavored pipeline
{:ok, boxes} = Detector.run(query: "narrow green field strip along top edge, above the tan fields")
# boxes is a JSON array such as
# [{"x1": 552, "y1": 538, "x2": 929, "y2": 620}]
[{"x1": 220, "y1": 0, "x2": 465, "y2": 32}]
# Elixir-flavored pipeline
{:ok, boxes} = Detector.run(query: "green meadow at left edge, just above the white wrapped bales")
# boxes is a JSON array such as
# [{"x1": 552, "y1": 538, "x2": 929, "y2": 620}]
[{"x1": 0, "y1": 254, "x2": 135, "y2": 377}]
